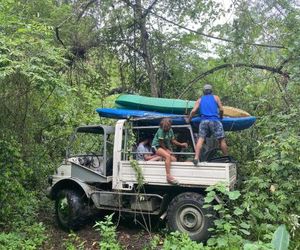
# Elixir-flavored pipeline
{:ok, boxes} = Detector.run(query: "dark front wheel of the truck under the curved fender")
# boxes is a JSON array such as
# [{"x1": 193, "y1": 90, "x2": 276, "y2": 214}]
[{"x1": 55, "y1": 189, "x2": 85, "y2": 231}]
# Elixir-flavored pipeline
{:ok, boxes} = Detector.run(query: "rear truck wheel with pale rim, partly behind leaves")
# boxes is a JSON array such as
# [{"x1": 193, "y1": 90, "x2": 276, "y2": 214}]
[{"x1": 167, "y1": 192, "x2": 213, "y2": 241}]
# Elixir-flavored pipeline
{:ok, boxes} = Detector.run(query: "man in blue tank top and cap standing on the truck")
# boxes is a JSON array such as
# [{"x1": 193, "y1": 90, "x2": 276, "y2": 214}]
[{"x1": 188, "y1": 84, "x2": 228, "y2": 166}]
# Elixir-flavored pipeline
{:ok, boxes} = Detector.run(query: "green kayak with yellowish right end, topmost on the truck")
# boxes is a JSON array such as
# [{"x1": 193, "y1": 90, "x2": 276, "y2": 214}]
[{"x1": 115, "y1": 94, "x2": 250, "y2": 117}]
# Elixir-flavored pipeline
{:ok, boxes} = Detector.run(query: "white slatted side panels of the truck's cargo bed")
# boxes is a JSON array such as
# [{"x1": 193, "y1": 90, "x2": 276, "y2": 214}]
[{"x1": 113, "y1": 161, "x2": 236, "y2": 190}]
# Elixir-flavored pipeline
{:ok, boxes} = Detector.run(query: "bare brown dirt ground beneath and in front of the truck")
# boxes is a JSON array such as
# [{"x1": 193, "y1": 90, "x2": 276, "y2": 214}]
[{"x1": 39, "y1": 209, "x2": 163, "y2": 250}]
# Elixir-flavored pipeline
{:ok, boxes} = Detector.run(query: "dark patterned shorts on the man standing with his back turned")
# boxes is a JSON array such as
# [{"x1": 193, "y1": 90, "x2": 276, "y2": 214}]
[{"x1": 199, "y1": 120, "x2": 225, "y2": 139}]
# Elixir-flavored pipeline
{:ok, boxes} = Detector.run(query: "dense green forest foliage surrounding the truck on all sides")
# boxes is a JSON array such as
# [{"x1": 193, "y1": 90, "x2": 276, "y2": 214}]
[{"x1": 0, "y1": 0, "x2": 300, "y2": 249}]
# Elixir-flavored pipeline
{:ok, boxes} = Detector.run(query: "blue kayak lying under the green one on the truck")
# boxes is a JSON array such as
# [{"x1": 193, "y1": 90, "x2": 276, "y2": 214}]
[{"x1": 96, "y1": 108, "x2": 256, "y2": 131}]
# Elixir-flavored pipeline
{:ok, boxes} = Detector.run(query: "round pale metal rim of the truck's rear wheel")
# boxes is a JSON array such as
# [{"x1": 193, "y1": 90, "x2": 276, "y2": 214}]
[{"x1": 176, "y1": 205, "x2": 204, "y2": 235}]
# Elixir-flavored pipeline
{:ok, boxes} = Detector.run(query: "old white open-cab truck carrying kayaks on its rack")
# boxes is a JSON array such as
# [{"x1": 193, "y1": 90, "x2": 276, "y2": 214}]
[{"x1": 48, "y1": 120, "x2": 236, "y2": 241}]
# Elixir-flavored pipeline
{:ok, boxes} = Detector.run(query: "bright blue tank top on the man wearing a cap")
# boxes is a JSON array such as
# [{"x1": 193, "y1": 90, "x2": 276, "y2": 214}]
[{"x1": 199, "y1": 95, "x2": 220, "y2": 121}]
